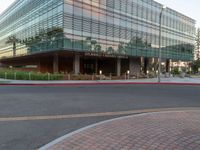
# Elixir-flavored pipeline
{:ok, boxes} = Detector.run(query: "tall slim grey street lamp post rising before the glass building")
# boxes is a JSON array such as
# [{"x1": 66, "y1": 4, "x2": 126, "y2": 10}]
[{"x1": 158, "y1": 6, "x2": 167, "y2": 83}]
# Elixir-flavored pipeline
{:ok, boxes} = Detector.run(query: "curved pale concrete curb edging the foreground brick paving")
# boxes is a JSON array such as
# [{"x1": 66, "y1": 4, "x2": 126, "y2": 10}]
[{"x1": 38, "y1": 109, "x2": 200, "y2": 150}]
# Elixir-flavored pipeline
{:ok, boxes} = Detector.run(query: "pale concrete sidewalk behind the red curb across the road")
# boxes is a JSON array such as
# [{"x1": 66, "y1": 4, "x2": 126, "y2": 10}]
[{"x1": 0, "y1": 78, "x2": 200, "y2": 85}]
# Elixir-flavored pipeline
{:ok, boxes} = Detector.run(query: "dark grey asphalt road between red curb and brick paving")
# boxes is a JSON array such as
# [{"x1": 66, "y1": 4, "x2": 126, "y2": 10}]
[{"x1": 0, "y1": 85, "x2": 200, "y2": 150}]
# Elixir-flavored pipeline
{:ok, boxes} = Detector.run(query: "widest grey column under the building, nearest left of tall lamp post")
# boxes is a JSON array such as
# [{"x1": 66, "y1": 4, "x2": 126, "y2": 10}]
[{"x1": 129, "y1": 57, "x2": 141, "y2": 74}]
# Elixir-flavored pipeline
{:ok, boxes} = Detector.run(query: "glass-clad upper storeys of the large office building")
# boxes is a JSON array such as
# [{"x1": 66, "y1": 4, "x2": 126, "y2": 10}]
[{"x1": 0, "y1": 0, "x2": 195, "y2": 72}]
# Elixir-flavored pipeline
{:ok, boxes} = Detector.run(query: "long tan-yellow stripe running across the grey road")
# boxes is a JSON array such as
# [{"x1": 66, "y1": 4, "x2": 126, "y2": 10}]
[{"x1": 0, "y1": 107, "x2": 200, "y2": 122}]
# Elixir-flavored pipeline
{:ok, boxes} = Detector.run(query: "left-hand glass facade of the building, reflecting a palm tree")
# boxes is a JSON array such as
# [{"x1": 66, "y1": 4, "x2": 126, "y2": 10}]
[{"x1": 0, "y1": 0, "x2": 63, "y2": 57}]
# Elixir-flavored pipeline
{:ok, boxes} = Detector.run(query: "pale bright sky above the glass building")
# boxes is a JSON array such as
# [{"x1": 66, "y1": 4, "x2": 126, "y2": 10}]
[{"x1": 0, "y1": 0, "x2": 200, "y2": 27}]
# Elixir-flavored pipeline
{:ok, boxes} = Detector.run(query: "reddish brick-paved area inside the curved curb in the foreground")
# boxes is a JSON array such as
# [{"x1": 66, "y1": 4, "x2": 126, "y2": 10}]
[{"x1": 40, "y1": 110, "x2": 200, "y2": 150}]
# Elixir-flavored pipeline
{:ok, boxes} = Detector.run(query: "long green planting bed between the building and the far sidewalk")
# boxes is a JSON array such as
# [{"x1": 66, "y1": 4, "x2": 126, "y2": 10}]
[{"x1": 0, "y1": 69, "x2": 158, "y2": 81}]
